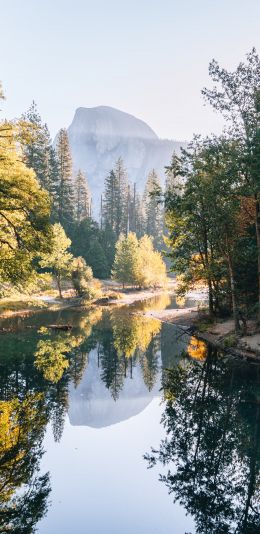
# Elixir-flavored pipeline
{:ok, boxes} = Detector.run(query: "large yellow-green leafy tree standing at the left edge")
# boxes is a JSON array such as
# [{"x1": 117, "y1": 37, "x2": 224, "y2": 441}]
[{"x1": 0, "y1": 123, "x2": 51, "y2": 285}]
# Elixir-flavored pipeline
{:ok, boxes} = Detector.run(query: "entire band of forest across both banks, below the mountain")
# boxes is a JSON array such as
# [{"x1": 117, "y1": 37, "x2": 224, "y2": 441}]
[{"x1": 0, "y1": 49, "x2": 260, "y2": 333}]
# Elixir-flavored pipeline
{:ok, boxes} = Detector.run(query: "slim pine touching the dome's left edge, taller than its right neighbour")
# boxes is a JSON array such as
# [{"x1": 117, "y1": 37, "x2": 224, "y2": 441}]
[{"x1": 56, "y1": 128, "x2": 75, "y2": 228}]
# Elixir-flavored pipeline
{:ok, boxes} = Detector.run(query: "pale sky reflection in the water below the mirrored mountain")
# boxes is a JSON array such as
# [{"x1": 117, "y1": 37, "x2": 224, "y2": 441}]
[{"x1": 39, "y1": 398, "x2": 193, "y2": 534}]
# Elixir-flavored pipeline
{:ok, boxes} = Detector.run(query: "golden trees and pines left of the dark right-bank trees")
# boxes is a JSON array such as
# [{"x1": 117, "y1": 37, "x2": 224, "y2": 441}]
[{"x1": 0, "y1": 91, "x2": 166, "y2": 299}]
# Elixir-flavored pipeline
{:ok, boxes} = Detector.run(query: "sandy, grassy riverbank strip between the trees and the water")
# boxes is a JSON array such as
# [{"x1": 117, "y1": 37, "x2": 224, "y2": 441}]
[{"x1": 0, "y1": 280, "x2": 260, "y2": 362}]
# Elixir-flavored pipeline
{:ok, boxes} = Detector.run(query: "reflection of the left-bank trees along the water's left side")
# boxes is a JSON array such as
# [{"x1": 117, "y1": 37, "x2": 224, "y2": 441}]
[{"x1": 0, "y1": 314, "x2": 101, "y2": 534}]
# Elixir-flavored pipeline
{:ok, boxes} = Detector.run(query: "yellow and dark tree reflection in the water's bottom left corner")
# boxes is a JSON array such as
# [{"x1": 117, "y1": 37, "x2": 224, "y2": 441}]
[{"x1": 0, "y1": 394, "x2": 50, "y2": 534}]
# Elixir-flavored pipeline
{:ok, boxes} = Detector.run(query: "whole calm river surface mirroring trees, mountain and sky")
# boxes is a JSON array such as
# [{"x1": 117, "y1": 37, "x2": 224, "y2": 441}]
[{"x1": 0, "y1": 295, "x2": 260, "y2": 534}]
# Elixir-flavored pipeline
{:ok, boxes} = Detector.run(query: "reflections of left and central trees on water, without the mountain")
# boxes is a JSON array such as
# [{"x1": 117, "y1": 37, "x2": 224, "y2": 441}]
[{"x1": 0, "y1": 297, "x2": 168, "y2": 534}]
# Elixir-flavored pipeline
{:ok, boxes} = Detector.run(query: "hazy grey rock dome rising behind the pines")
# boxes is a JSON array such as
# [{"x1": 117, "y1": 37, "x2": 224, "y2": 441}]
[{"x1": 68, "y1": 106, "x2": 186, "y2": 216}]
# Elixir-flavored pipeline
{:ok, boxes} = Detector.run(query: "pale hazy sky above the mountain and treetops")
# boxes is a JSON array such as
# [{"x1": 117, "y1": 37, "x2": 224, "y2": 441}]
[{"x1": 0, "y1": 0, "x2": 260, "y2": 139}]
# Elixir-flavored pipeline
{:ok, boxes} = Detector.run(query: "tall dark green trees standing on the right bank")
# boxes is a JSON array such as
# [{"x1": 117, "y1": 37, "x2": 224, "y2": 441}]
[{"x1": 164, "y1": 49, "x2": 260, "y2": 332}]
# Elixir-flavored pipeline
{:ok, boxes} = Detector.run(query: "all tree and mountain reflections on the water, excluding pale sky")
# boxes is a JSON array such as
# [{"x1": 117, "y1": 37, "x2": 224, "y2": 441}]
[{"x1": 0, "y1": 295, "x2": 260, "y2": 534}]
